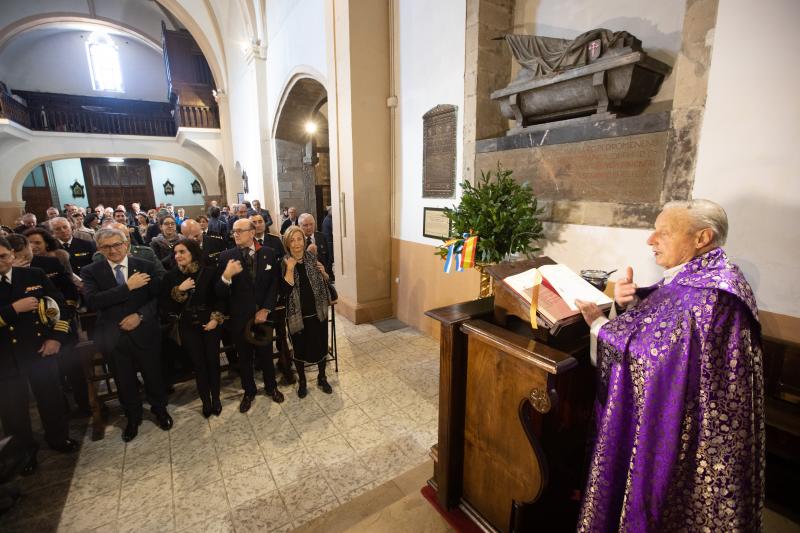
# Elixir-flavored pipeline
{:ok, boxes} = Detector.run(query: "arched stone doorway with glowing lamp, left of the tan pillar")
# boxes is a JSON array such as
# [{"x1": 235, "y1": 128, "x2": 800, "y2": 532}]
[{"x1": 273, "y1": 73, "x2": 332, "y2": 221}]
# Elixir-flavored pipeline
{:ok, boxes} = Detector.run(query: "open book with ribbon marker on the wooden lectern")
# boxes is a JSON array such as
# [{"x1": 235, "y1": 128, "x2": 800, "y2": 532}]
[{"x1": 502, "y1": 264, "x2": 613, "y2": 328}]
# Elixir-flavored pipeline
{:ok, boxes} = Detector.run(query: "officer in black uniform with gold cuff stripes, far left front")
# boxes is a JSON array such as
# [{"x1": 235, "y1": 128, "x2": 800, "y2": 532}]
[{"x1": 0, "y1": 237, "x2": 78, "y2": 474}]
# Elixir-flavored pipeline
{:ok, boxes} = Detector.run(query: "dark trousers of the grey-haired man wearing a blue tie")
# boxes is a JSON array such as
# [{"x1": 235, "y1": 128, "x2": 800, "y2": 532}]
[{"x1": 105, "y1": 333, "x2": 167, "y2": 420}]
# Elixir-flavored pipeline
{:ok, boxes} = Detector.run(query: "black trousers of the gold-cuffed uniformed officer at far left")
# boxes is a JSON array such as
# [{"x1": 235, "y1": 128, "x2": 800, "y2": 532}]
[{"x1": 0, "y1": 354, "x2": 69, "y2": 449}]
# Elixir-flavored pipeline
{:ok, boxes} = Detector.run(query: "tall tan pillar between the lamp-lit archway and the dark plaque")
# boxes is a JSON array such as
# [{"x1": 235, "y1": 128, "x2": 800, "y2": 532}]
[{"x1": 327, "y1": 0, "x2": 392, "y2": 323}]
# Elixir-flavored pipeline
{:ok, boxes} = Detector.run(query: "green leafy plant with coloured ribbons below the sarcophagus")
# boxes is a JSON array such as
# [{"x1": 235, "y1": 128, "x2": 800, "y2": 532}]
[{"x1": 436, "y1": 164, "x2": 542, "y2": 263}]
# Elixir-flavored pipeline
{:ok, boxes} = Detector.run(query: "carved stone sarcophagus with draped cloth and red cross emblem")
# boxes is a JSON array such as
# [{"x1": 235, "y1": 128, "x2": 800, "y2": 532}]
[{"x1": 491, "y1": 29, "x2": 671, "y2": 135}]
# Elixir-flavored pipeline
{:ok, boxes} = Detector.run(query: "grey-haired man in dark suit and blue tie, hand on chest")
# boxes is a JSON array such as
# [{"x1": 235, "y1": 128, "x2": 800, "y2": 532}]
[{"x1": 81, "y1": 228, "x2": 172, "y2": 442}]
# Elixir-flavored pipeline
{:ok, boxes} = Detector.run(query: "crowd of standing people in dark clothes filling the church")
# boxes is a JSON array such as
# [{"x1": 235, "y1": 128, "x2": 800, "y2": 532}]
[{"x1": 0, "y1": 200, "x2": 336, "y2": 474}]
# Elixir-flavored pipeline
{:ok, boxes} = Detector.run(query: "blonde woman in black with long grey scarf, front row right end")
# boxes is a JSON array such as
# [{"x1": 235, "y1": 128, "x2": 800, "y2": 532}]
[{"x1": 283, "y1": 226, "x2": 333, "y2": 398}]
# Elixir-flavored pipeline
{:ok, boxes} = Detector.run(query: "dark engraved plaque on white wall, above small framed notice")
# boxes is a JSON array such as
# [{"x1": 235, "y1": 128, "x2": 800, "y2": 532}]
[{"x1": 422, "y1": 105, "x2": 458, "y2": 198}]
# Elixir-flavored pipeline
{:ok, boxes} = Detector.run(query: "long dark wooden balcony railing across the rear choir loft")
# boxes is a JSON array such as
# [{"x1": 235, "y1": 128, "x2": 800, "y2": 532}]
[{"x1": 0, "y1": 86, "x2": 219, "y2": 137}]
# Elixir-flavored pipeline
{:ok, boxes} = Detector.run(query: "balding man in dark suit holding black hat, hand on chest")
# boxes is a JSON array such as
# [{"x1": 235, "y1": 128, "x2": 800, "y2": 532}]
[{"x1": 217, "y1": 218, "x2": 283, "y2": 413}]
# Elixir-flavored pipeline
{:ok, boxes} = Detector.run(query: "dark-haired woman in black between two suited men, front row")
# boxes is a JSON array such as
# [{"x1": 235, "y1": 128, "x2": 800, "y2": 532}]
[{"x1": 159, "y1": 239, "x2": 224, "y2": 418}]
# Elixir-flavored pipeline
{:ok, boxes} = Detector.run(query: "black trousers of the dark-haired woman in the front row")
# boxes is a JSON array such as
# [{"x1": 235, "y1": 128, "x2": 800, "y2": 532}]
[{"x1": 179, "y1": 323, "x2": 220, "y2": 405}]
